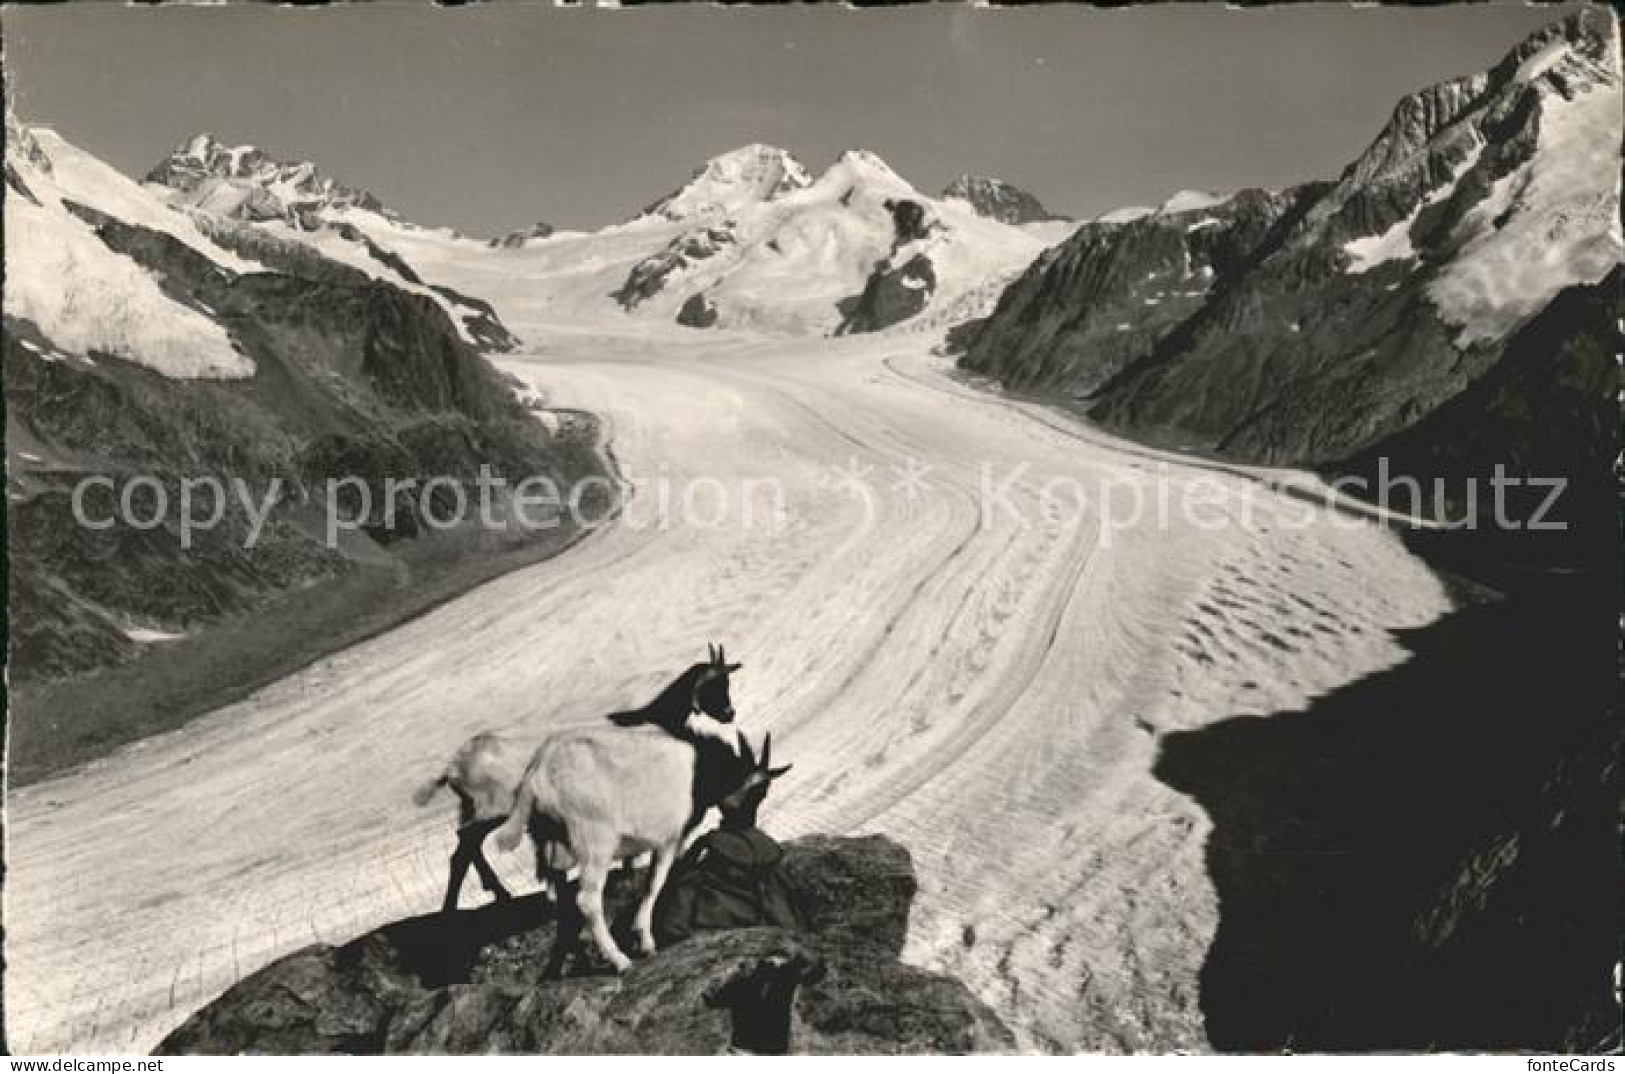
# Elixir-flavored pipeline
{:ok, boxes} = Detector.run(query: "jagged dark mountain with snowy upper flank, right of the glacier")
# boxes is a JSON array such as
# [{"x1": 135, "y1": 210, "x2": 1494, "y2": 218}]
[{"x1": 962, "y1": 8, "x2": 1622, "y2": 549}]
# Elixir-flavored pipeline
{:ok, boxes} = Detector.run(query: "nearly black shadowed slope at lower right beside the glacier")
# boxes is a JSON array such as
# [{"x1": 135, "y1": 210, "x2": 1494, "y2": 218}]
[{"x1": 1155, "y1": 549, "x2": 1622, "y2": 1053}]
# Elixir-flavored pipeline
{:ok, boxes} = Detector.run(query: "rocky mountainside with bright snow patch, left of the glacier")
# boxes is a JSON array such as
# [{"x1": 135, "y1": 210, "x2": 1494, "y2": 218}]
[{"x1": 5, "y1": 115, "x2": 601, "y2": 778}]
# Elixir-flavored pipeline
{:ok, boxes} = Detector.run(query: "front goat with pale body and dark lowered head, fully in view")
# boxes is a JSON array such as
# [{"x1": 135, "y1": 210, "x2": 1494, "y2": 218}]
[{"x1": 497, "y1": 705, "x2": 765, "y2": 973}]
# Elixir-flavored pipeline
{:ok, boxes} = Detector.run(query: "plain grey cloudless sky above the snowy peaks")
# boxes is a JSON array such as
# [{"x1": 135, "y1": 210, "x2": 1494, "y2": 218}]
[{"x1": 0, "y1": 2, "x2": 1568, "y2": 236}]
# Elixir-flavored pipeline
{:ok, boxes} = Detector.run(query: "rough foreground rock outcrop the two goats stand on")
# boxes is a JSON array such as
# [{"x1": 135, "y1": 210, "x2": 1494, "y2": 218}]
[{"x1": 158, "y1": 837, "x2": 1014, "y2": 1055}]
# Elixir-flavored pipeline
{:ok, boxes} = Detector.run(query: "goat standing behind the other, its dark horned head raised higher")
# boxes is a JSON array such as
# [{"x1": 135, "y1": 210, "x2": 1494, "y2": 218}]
[{"x1": 413, "y1": 645, "x2": 739, "y2": 910}]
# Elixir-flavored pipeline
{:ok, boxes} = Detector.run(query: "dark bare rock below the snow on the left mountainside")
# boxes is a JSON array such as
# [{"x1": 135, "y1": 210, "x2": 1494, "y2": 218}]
[{"x1": 5, "y1": 210, "x2": 595, "y2": 682}]
